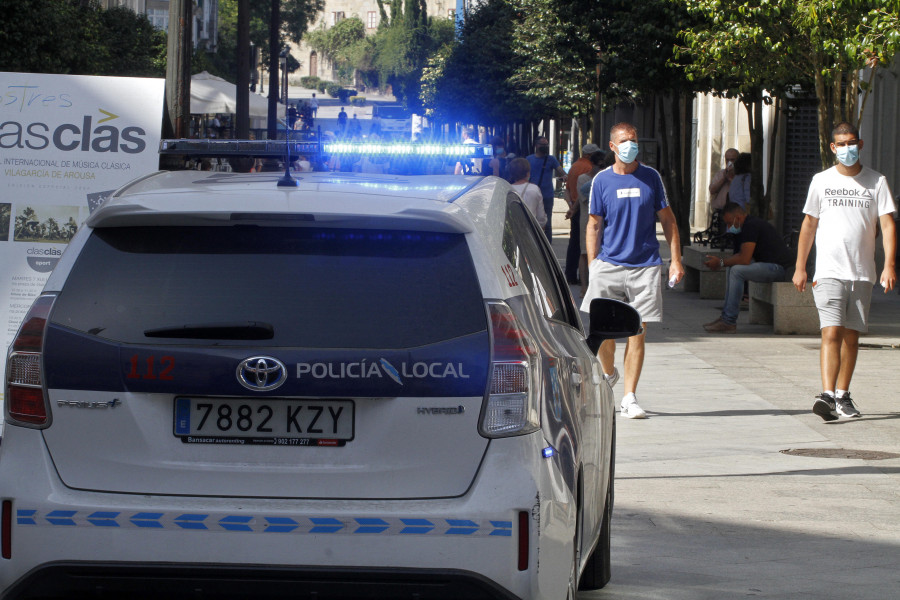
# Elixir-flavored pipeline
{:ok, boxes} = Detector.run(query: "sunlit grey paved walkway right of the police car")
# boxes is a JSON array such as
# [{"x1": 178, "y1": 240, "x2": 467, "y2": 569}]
[{"x1": 554, "y1": 227, "x2": 900, "y2": 600}]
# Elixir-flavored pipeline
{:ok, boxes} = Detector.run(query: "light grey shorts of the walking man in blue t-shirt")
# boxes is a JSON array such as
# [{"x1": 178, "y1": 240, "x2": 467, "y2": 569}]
[{"x1": 581, "y1": 259, "x2": 662, "y2": 323}]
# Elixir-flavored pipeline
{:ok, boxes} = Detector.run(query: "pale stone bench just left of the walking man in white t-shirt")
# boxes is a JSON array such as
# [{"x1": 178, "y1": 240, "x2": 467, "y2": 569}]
[{"x1": 750, "y1": 281, "x2": 819, "y2": 335}]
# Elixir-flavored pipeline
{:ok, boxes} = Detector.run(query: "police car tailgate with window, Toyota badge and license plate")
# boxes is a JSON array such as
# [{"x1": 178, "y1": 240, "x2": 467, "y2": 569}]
[{"x1": 44, "y1": 223, "x2": 490, "y2": 498}]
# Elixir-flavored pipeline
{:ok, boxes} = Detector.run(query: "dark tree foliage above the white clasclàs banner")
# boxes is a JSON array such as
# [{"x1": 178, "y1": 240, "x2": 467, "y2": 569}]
[{"x1": 0, "y1": 0, "x2": 166, "y2": 76}]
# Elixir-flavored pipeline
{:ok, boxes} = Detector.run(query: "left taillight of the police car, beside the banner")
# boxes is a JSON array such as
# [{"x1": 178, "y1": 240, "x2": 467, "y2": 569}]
[{"x1": 5, "y1": 295, "x2": 56, "y2": 427}]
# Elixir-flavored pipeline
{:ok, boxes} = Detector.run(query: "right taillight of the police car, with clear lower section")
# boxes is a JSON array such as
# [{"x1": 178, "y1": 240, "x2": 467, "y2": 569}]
[{"x1": 481, "y1": 302, "x2": 541, "y2": 437}]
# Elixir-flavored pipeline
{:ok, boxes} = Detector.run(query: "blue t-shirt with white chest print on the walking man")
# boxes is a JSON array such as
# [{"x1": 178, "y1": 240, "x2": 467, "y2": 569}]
[{"x1": 590, "y1": 164, "x2": 669, "y2": 267}]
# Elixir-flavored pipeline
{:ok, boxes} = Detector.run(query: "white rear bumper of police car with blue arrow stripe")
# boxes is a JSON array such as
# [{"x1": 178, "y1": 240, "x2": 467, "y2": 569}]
[{"x1": 0, "y1": 427, "x2": 575, "y2": 600}]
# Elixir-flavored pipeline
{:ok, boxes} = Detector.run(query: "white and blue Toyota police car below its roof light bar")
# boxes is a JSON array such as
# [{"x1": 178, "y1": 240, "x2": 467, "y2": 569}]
[{"x1": 0, "y1": 139, "x2": 640, "y2": 600}]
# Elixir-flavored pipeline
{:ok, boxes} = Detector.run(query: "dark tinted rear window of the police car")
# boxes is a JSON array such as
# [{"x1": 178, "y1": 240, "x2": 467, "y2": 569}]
[{"x1": 52, "y1": 226, "x2": 486, "y2": 348}]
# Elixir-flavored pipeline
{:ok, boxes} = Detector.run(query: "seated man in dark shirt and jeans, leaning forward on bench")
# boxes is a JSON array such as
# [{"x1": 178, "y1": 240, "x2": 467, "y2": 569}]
[{"x1": 703, "y1": 202, "x2": 794, "y2": 333}]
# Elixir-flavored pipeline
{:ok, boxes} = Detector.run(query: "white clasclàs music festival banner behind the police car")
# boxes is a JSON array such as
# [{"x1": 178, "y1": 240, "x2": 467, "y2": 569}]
[{"x1": 0, "y1": 72, "x2": 164, "y2": 423}]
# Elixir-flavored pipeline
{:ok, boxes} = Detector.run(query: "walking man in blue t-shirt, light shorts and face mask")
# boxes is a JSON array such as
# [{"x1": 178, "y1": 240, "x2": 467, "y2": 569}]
[{"x1": 581, "y1": 123, "x2": 684, "y2": 419}]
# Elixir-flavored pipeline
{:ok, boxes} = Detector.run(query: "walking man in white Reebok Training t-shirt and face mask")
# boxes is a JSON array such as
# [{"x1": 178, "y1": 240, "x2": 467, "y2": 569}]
[{"x1": 794, "y1": 123, "x2": 897, "y2": 421}]
